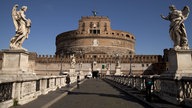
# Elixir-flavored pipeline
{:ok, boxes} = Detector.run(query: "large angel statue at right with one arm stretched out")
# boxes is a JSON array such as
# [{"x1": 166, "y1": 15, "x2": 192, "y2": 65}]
[{"x1": 161, "y1": 5, "x2": 190, "y2": 49}]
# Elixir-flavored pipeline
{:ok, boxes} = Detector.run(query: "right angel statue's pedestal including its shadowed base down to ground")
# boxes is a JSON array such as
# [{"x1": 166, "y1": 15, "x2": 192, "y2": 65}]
[{"x1": 159, "y1": 49, "x2": 192, "y2": 104}]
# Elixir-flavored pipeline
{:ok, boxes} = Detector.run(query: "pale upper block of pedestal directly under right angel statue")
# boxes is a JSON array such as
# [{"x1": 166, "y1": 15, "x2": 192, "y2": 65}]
[{"x1": 162, "y1": 49, "x2": 192, "y2": 78}]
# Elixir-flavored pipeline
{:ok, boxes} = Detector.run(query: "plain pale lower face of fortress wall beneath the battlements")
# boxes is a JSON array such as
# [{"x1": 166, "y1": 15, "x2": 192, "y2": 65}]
[{"x1": 35, "y1": 60, "x2": 156, "y2": 75}]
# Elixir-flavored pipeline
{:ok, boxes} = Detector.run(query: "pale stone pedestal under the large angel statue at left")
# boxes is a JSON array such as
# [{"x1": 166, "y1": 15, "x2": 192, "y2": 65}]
[{"x1": 0, "y1": 50, "x2": 36, "y2": 81}]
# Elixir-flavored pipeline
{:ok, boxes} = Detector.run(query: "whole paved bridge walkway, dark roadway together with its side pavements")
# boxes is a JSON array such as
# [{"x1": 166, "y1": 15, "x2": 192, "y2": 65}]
[{"x1": 13, "y1": 79, "x2": 184, "y2": 108}]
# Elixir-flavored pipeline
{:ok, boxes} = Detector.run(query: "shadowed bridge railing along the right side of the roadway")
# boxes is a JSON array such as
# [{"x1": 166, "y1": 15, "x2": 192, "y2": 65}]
[{"x1": 106, "y1": 75, "x2": 192, "y2": 107}]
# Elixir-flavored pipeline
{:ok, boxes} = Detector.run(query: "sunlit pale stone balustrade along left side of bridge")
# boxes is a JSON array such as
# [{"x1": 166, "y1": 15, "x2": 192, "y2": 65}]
[{"x1": 0, "y1": 76, "x2": 79, "y2": 108}]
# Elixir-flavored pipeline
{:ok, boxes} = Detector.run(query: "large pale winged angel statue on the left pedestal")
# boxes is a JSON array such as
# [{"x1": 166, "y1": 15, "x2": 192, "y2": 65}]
[{"x1": 10, "y1": 4, "x2": 31, "y2": 50}]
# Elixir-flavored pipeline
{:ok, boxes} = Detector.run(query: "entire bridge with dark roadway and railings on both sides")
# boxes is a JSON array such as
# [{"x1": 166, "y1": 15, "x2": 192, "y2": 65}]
[{"x1": 0, "y1": 76, "x2": 192, "y2": 108}]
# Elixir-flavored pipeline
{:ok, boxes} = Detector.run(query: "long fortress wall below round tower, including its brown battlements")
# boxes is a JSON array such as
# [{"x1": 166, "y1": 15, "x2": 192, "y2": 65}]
[{"x1": 0, "y1": 52, "x2": 165, "y2": 75}]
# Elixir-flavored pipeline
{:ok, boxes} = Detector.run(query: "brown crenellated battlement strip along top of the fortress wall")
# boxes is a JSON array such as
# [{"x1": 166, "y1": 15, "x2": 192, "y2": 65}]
[{"x1": 32, "y1": 54, "x2": 162, "y2": 63}]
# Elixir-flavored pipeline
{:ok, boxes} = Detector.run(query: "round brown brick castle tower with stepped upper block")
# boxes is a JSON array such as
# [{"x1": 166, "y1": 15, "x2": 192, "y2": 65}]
[{"x1": 55, "y1": 16, "x2": 135, "y2": 55}]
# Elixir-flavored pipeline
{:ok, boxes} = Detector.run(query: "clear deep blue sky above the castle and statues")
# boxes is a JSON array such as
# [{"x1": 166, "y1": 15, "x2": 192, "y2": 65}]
[{"x1": 0, "y1": 0, "x2": 192, "y2": 55}]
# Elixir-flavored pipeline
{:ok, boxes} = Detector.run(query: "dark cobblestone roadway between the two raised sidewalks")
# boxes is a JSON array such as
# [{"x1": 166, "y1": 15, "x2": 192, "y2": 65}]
[{"x1": 49, "y1": 79, "x2": 152, "y2": 108}]
